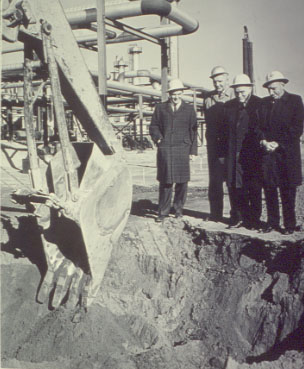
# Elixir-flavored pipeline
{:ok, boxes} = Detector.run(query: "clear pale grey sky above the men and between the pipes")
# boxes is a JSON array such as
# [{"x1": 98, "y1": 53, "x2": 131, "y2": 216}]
[{"x1": 3, "y1": 0, "x2": 304, "y2": 98}]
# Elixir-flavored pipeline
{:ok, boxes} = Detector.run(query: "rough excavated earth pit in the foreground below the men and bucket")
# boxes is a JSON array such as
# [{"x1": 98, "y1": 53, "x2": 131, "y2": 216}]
[{"x1": 1, "y1": 216, "x2": 304, "y2": 369}]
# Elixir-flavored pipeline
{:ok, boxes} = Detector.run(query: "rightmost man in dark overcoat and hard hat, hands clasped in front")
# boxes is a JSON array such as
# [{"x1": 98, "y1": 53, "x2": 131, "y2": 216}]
[{"x1": 259, "y1": 71, "x2": 304, "y2": 234}]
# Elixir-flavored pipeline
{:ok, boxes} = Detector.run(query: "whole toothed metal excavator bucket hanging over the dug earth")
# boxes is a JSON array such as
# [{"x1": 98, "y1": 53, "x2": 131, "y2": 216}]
[{"x1": 36, "y1": 143, "x2": 132, "y2": 307}]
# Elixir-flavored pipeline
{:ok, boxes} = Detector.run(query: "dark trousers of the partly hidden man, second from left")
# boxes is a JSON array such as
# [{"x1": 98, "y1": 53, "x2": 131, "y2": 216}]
[{"x1": 207, "y1": 146, "x2": 225, "y2": 220}]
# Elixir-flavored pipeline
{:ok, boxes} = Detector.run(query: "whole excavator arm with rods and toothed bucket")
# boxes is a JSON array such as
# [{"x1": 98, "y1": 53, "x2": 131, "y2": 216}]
[{"x1": 2, "y1": 0, "x2": 132, "y2": 308}]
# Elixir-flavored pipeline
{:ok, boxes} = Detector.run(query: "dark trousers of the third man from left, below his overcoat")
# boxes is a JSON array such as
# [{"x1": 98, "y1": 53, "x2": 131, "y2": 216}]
[{"x1": 228, "y1": 180, "x2": 262, "y2": 225}]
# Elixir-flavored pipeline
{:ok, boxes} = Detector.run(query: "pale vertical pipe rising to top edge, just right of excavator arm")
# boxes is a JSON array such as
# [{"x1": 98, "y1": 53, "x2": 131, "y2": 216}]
[{"x1": 96, "y1": 0, "x2": 107, "y2": 108}]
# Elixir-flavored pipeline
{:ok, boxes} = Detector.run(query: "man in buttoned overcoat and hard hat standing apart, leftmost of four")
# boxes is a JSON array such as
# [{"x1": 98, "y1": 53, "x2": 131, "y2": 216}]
[{"x1": 150, "y1": 79, "x2": 197, "y2": 222}]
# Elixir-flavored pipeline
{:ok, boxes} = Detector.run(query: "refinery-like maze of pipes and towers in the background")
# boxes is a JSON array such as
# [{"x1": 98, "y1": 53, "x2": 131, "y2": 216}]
[{"x1": 2, "y1": 0, "x2": 204, "y2": 149}]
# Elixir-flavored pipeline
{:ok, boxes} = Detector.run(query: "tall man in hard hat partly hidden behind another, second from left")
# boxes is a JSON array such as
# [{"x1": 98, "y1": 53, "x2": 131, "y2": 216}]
[{"x1": 203, "y1": 66, "x2": 234, "y2": 222}]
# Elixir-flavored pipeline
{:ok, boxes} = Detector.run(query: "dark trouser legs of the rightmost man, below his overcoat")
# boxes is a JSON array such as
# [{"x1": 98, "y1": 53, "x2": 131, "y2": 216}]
[{"x1": 264, "y1": 186, "x2": 297, "y2": 228}]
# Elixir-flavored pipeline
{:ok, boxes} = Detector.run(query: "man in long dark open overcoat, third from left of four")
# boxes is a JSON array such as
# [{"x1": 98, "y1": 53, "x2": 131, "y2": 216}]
[{"x1": 219, "y1": 74, "x2": 262, "y2": 229}]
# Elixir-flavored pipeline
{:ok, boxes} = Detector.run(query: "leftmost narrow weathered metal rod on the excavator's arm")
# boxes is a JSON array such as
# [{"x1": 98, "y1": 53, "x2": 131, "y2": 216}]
[{"x1": 23, "y1": 43, "x2": 41, "y2": 189}]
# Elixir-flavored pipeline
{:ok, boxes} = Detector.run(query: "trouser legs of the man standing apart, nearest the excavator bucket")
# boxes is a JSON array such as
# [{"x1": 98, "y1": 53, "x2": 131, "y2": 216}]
[{"x1": 158, "y1": 182, "x2": 188, "y2": 215}]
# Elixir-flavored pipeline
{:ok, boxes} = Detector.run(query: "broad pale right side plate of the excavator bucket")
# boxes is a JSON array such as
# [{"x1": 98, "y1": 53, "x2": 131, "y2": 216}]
[{"x1": 79, "y1": 145, "x2": 132, "y2": 304}]
